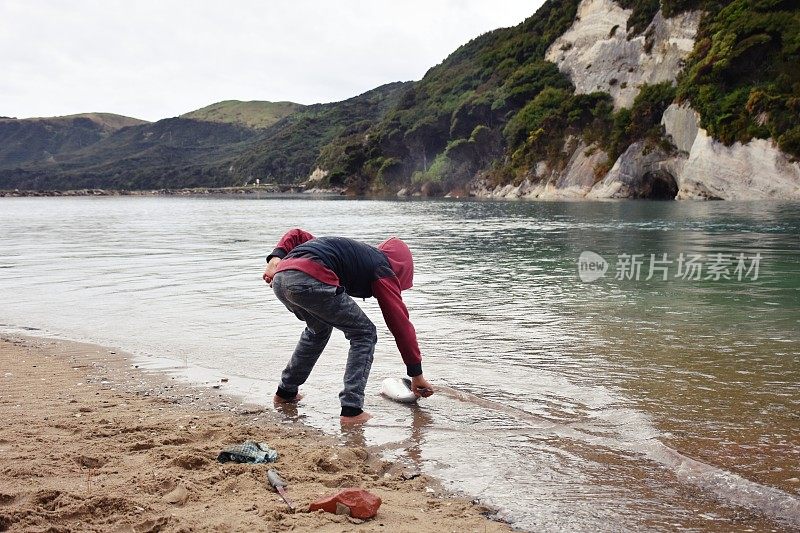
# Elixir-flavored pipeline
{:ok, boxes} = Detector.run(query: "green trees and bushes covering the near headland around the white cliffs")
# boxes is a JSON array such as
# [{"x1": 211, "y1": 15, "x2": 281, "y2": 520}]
[{"x1": 304, "y1": 0, "x2": 800, "y2": 191}]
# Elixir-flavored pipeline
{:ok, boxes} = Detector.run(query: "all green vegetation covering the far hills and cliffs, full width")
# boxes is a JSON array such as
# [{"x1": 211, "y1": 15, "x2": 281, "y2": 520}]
[{"x1": 0, "y1": 0, "x2": 800, "y2": 194}]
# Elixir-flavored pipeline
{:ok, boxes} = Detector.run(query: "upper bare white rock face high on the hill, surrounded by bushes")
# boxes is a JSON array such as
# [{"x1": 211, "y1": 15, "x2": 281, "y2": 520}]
[{"x1": 545, "y1": 0, "x2": 701, "y2": 109}]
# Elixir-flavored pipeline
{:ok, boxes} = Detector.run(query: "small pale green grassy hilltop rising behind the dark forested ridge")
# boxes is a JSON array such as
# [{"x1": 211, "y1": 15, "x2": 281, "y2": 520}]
[{"x1": 181, "y1": 100, "x2": 303, "y2": 129}]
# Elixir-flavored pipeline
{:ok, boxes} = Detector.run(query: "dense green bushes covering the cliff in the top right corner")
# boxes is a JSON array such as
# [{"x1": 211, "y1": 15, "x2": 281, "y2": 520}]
[{"x1": 678, "y1": 0, "x2": 800, "y2": 156}]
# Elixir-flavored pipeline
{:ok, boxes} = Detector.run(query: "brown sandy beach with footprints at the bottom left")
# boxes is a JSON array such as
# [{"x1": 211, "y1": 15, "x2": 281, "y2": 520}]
[{"x1": 0, "y1": 336, "x2": 510, "y2": 533}]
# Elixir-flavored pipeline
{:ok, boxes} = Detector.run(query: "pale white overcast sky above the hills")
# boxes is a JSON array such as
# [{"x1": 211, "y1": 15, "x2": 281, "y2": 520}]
[{"x1": 0, "y1": 0, "x2": 543, "y2": 120}]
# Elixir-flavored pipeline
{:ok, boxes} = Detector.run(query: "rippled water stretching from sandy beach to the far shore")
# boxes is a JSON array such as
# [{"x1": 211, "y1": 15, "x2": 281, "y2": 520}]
[{"x1": 0, "y1": 197, "x2": 800, "y2": 531}]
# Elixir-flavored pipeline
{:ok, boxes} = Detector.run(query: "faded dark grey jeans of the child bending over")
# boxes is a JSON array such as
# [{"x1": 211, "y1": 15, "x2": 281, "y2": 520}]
[{"x1": 272, "y1": 270, "x2": 378, "y2": 416}]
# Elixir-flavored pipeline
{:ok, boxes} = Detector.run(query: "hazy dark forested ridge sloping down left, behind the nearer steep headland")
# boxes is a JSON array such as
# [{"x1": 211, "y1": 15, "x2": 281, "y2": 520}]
[{"x1": 0, "y1": 83, "x2": 404, "y2": 189}]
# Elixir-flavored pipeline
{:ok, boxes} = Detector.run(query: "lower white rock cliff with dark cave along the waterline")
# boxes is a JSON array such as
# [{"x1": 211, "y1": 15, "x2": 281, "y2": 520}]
[{"x1": 473, "y1": 104, "x2": 800, "y2": 200}]
